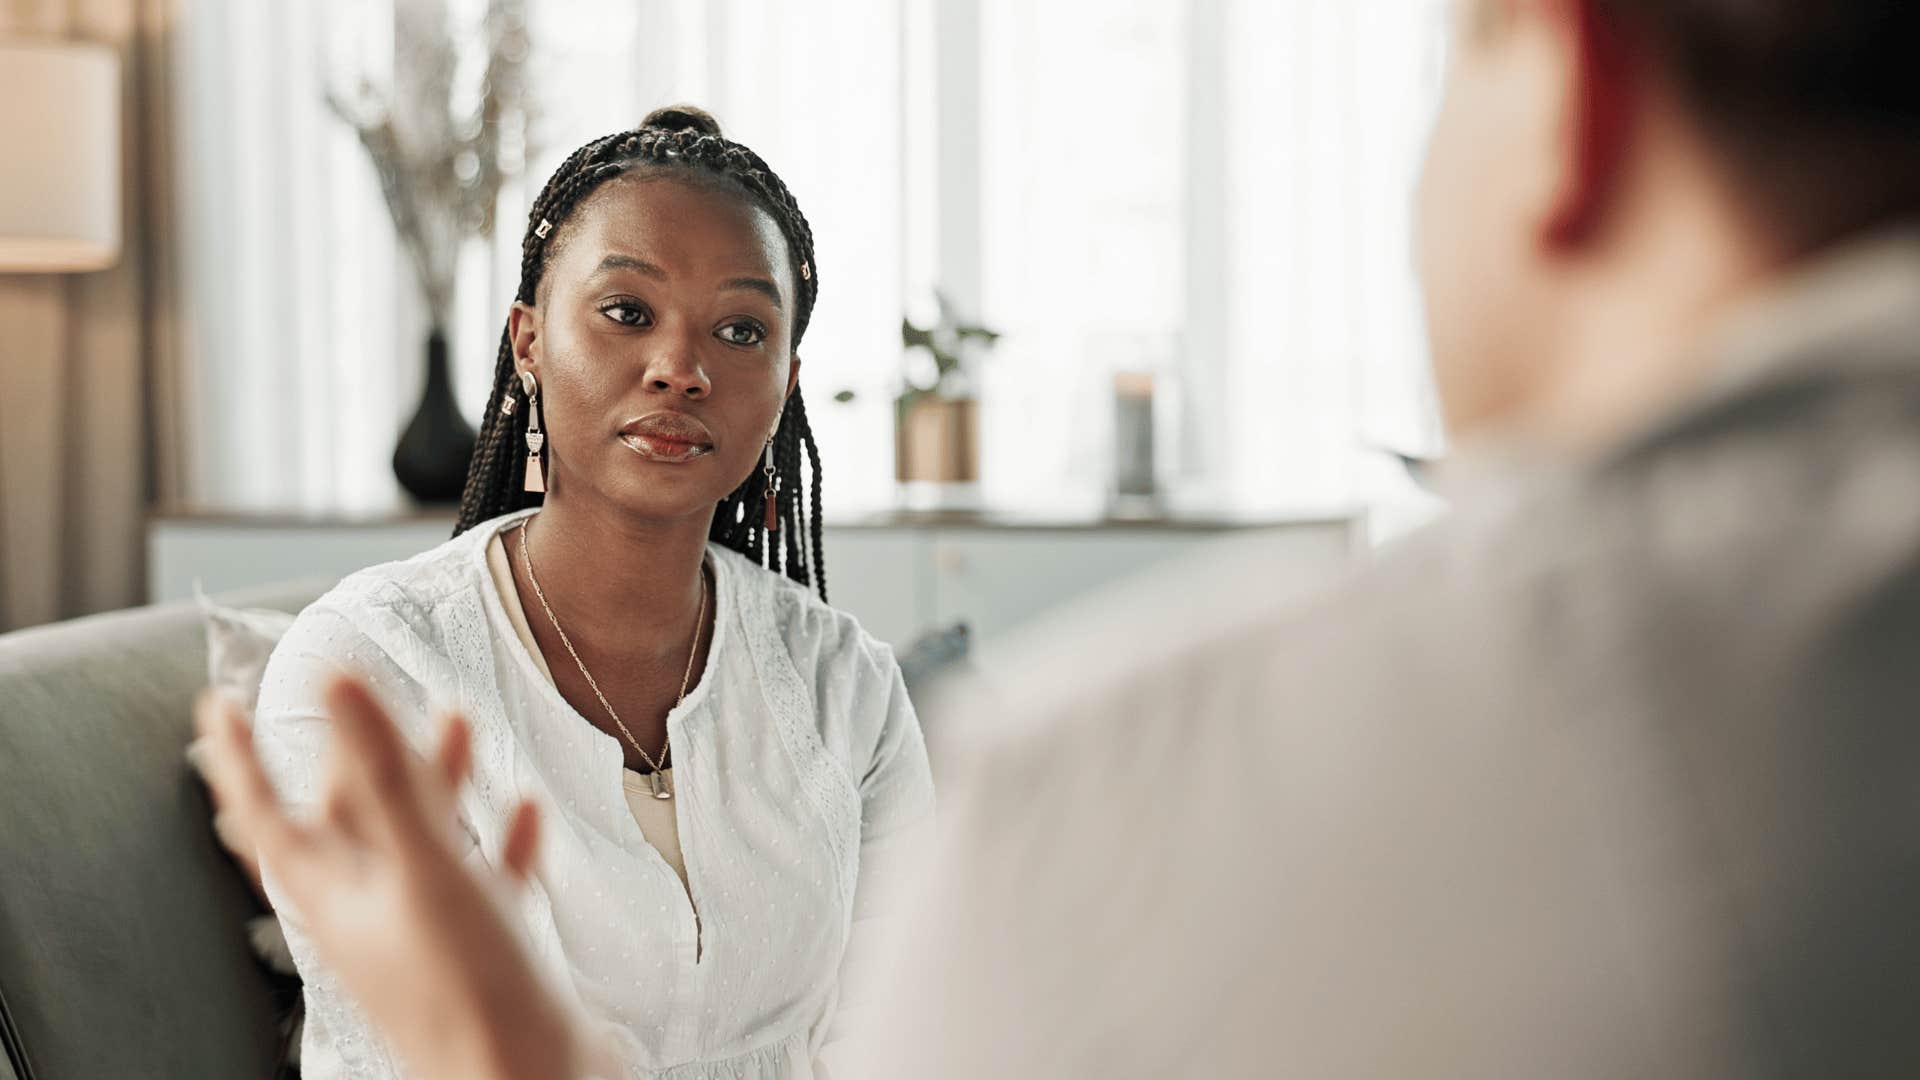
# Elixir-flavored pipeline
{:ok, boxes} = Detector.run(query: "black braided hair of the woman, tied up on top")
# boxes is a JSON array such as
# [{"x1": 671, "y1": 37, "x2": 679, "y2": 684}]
[{"x1": 453, "y1": 106, "x2": 828, "y2": 600}]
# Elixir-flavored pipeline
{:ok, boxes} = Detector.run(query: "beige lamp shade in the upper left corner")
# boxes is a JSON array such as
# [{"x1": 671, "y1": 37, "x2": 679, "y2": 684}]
[{"x1": 0, "y1": 40, "x2": 121, "y2": 273}]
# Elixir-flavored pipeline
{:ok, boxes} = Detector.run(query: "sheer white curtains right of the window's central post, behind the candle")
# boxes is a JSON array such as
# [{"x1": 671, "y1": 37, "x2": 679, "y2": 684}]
[{"x1": 981, "y1": 0, "x2": 1442, "y2": 513}]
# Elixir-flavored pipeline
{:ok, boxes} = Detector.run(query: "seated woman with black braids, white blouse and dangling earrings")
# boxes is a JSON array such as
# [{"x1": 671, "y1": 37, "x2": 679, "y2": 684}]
[{"x1": 243, "y1": 108, "x2": 931, "y2": 1080}]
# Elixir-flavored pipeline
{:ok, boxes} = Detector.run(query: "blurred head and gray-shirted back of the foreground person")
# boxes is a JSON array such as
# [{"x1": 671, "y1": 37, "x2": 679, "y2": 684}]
[{"x1": 198, "y1": 0, "x2": 1920, "y2": 1080}]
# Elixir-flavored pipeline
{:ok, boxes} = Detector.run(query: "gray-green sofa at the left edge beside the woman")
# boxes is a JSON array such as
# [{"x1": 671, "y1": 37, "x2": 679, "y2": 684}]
[{"x1": 0, "y1": 584, "x2": 323, "y2": 1080}]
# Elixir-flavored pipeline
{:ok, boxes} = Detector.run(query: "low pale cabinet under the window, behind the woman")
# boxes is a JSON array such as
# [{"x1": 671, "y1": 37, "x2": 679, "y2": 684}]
[{"x1": 148, "y1": 515, "x2": 1357, "y2": 648}]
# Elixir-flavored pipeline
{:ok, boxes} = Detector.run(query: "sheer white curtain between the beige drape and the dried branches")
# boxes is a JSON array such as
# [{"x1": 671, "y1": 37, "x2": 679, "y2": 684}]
[{"x1": 175, "y1": 0, "x2": 408, "y2": 511}]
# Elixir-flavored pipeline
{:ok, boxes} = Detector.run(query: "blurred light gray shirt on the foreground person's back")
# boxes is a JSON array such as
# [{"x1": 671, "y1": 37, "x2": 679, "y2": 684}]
[{"x1": 876, "y1": 228, "x2": 1920, "y2": 1080}]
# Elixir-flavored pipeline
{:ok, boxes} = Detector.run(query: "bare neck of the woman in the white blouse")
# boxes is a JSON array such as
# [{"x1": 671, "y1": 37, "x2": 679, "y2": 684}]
[{"x1": 511, "y1": 496, "x2": 712, "y2": 650}]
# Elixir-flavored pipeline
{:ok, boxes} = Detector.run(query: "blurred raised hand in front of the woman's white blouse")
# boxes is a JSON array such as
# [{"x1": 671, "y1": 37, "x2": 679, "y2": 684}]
[{"x1": 196, "y1": 678, "x2": 618, "y2": 1080}]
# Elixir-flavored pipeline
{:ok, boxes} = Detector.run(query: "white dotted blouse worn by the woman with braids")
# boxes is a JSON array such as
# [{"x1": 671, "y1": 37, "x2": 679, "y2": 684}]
[{"x1": 255, "y1": 511, "x2": 933, "y2": 1080}]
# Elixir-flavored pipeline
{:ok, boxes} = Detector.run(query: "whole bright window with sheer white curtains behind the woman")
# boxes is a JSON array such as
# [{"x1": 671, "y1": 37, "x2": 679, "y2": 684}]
[{"x1": 179, "y1": 0, "x2": 1442, "y2": 513}]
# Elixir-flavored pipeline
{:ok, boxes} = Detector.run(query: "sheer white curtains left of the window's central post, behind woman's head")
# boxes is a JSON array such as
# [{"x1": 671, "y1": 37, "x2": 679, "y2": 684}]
[{"x1": 179, "y1": 0, "x2": 902, "y2": 513}]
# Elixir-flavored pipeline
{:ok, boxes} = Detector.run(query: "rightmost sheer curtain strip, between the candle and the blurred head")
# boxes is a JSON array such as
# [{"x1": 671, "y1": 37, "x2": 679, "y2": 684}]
[{"x1": 1221, "y1": 0, "x2": 1444, "y2": 505}]
